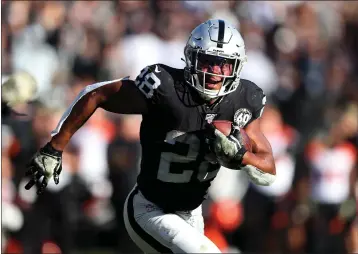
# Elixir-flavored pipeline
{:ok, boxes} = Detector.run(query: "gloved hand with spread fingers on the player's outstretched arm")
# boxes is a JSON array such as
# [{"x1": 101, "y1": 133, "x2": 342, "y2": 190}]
[{"x1": 25, "y1": 143, "x2": 62, "y2": 195}]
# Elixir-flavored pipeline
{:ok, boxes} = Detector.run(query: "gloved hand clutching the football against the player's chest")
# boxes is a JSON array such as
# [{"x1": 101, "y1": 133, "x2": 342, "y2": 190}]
[{"x1": 211, "y1": 125, "x2": 247, "y2": 169}]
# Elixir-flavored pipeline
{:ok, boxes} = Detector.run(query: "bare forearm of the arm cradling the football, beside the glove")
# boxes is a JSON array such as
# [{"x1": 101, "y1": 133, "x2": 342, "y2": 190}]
[{"x1": 242, "y1": 151, "x2": 276, "y2": 175}]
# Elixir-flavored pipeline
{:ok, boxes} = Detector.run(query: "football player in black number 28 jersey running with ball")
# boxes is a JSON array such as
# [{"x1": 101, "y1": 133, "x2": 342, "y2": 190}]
[{"x1": 25, "y1": 20, "x2": 276, "y2": 253}]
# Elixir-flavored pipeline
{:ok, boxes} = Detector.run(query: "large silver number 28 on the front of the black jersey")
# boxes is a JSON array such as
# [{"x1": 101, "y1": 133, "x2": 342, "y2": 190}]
[{"x1": 157, "y1": 131, "x2": 219, "y2": 183}]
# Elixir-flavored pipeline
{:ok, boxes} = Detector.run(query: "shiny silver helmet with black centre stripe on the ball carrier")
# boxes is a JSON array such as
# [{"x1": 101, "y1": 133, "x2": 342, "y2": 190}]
[{"x1": 184, "y1": 19, "x2": 247, "y2": 99}]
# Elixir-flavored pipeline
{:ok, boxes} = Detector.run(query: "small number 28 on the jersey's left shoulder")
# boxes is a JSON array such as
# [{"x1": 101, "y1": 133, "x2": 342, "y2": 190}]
[{"x1": 135, "y1": 66, "x2": 161, "y2": 99}]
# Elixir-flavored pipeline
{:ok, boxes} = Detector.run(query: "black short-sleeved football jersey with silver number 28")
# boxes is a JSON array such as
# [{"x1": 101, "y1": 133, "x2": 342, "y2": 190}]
[{"x1": 135, "y1": 64, "x2": 266, "y2": 211}]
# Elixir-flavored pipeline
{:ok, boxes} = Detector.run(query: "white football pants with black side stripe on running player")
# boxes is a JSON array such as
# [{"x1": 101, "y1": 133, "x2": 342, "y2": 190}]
[{"x1": 123, "y1": 187, "x2": 220, "y2": 253}]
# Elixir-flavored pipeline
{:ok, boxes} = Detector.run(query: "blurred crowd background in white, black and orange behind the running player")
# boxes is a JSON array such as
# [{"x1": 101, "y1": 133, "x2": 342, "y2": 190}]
[{"x1": 1, "y1": 0, "x2": 358, "y2": 254}]
